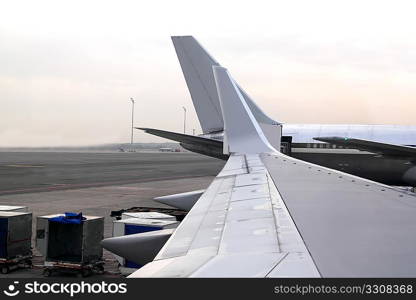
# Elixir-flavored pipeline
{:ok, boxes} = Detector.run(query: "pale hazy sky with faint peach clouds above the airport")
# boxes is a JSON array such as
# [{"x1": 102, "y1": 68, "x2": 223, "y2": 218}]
[{"x1": 0, "y1": 0, "x2": 416, "y2": 147}]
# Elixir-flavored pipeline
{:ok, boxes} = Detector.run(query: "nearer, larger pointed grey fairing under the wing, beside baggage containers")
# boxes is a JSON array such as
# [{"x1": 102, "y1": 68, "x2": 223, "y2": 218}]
[{"x1": 101, "y1": 229, "x2": 175, "y2": 265}]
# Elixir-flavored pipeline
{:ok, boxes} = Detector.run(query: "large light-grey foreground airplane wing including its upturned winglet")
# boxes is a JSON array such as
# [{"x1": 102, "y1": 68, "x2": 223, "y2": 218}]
[{"x1": 130, "y1": 67, "x2": 416, "y2": 277}]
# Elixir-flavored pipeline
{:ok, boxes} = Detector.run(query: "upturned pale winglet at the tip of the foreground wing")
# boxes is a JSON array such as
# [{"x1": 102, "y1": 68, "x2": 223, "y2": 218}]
[{"x1": 213, "y1": 66, "x2": 278, "y2": 154}]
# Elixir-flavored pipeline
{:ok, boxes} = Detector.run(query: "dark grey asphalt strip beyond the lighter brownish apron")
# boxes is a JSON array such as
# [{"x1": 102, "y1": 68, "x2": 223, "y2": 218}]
[{"x1": 0, "y1": 152, "x2": 224, "y2": 195}]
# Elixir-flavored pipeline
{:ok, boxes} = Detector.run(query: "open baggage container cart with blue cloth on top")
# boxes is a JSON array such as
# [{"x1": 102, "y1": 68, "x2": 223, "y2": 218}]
[{"x1": 36, "y1": 213, "x2": 104, "y2": 277}]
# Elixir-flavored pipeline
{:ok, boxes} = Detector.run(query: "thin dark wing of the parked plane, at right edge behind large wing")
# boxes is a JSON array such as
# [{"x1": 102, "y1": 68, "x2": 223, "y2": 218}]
[{"x1": 314, "y1": 136, "x2": 416, "y2": 159}]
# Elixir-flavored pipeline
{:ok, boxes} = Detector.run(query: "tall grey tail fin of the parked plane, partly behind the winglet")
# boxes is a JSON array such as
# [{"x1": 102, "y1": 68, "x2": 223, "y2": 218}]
[{"x1": 172, "y1": 36, "x2": 280, "y2": 137}]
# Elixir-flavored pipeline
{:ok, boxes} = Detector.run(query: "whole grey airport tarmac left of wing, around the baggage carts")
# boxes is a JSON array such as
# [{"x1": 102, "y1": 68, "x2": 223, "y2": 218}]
[{"x1": 0, "y1": 152, "x2": 225, "y2": 278}]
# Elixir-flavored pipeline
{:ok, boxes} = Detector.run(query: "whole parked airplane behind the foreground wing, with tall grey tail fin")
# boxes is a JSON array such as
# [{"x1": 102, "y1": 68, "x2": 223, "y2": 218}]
[{"x1": 138, "y1": 36, "x2": 416, "y2": 186}]
